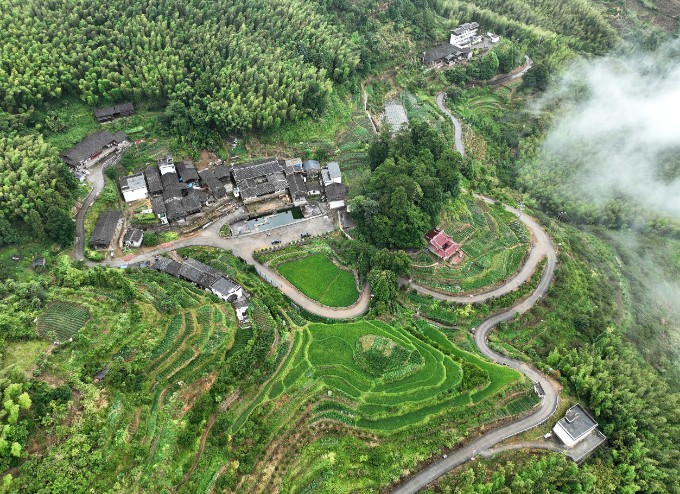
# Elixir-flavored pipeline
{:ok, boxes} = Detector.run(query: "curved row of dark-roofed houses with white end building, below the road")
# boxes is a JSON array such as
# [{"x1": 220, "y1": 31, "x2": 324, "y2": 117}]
[{"x1": 149, "y1": 256, "x2": 248, "y2": 325}]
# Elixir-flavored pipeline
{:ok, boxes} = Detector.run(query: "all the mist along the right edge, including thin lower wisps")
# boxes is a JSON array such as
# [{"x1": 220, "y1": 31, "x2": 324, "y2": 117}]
[{"x1": 536, "y1": 40, "x2": 680, "y2": 371}]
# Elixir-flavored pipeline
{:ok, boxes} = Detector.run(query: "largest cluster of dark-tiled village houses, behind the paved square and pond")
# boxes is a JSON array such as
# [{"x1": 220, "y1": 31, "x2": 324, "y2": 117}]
[{"x1": 75, "y1": 150, "x2": 348, "y2": 250}]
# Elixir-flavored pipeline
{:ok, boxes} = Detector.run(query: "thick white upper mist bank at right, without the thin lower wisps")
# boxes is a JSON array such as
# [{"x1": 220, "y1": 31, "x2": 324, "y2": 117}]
[{"x1": 539, "y1": 40, "x2": 680, "y2": 219}]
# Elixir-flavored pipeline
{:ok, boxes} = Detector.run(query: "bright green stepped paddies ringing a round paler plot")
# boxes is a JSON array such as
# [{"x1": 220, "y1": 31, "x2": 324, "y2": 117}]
[{"x1": 263, "y1": 321, "x2": 521, "y2": 433}]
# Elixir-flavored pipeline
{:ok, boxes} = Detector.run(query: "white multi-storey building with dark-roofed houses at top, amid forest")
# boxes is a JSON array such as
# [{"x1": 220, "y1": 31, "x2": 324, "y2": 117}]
[{"x1": 420, "y1": 22, "x2": 500, "y2": 68}]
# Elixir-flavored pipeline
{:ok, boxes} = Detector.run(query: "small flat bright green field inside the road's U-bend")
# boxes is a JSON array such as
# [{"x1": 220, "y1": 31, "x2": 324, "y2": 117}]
[{"x1": 277, "y1": 254, "x2": 359, "y2": 307}]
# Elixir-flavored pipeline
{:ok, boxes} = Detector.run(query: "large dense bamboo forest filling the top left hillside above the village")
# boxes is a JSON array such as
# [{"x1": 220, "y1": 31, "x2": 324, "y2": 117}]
[{"x1": 0, "y1": 0, "x2": 359, "y2": 137}]
